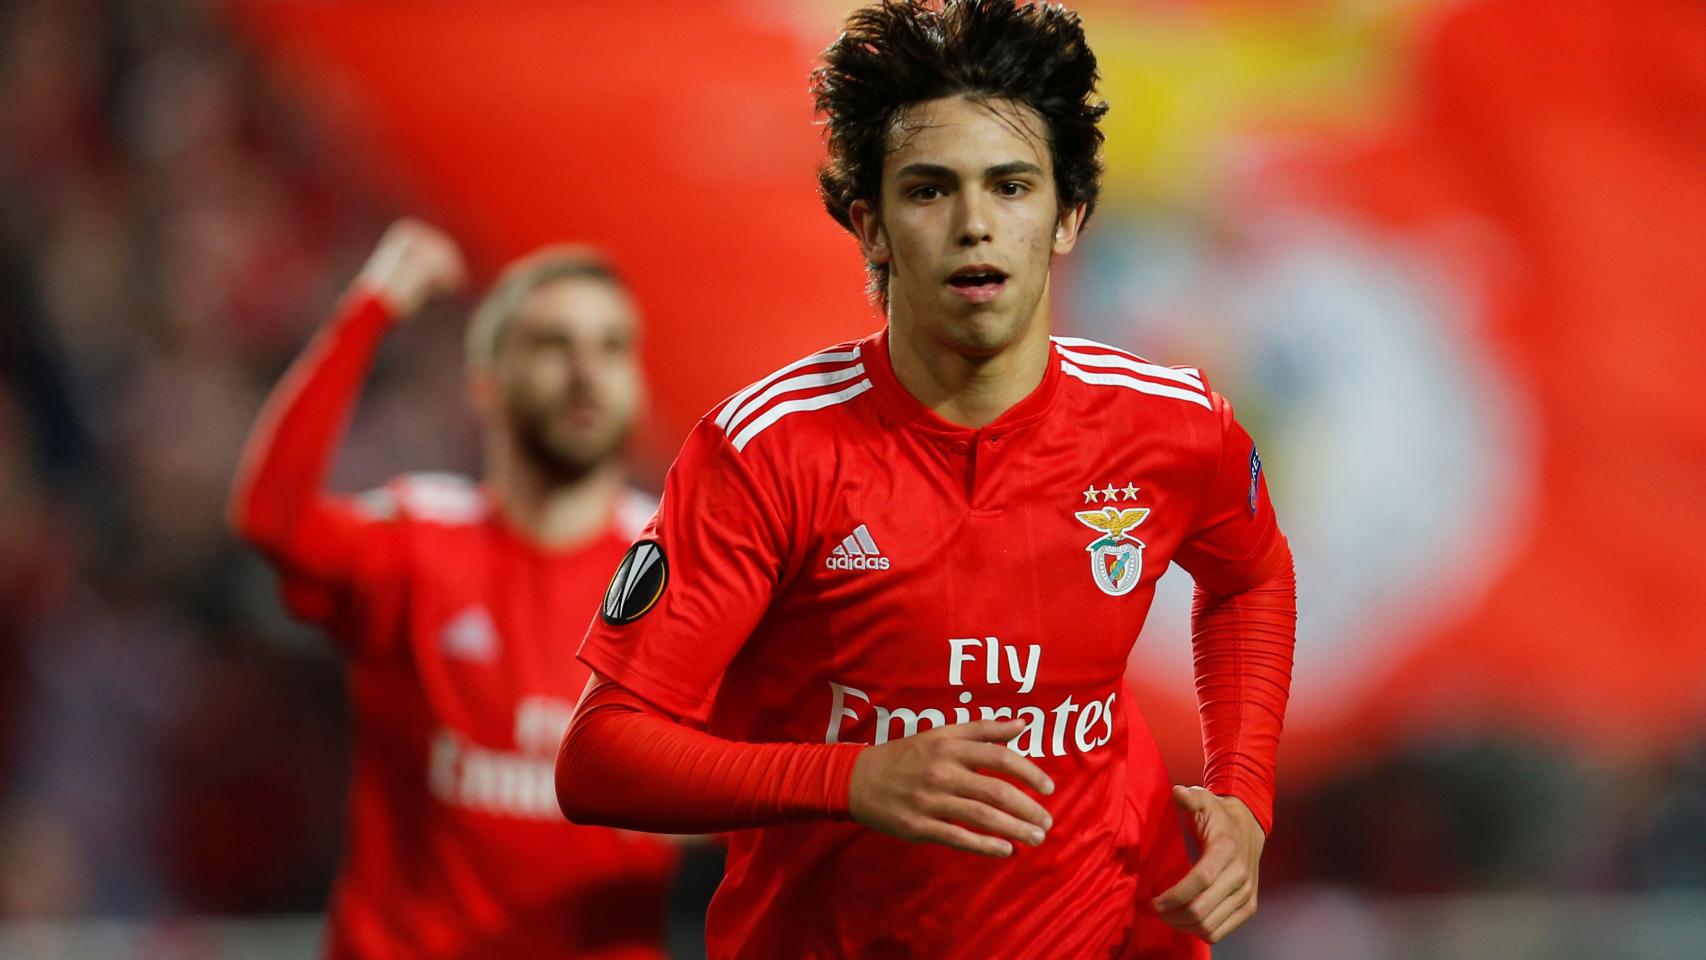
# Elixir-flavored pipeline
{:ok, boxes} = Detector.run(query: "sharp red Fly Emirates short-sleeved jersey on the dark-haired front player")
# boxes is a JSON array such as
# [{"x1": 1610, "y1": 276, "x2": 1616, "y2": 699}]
[{"x1": 580, "y1": 333, "x2": 1286, "y2": 958}]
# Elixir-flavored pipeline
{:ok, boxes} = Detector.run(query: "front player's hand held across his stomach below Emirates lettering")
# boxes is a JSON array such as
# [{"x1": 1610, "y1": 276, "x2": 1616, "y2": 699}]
[{"x1": 850, "y1": 720, "x2": 1054, "y2": 856}]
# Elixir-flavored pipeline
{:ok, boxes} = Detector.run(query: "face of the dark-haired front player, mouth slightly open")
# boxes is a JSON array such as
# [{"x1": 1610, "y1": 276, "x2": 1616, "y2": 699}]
[{"x1": 855, "y1": 95, "x2": 1078, "y2": 356}]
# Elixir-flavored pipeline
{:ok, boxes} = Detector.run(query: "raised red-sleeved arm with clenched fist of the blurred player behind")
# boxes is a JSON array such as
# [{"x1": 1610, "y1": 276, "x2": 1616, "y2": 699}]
[{"x1": 229, "y1": 220, "x2": 464, "y2": 583}]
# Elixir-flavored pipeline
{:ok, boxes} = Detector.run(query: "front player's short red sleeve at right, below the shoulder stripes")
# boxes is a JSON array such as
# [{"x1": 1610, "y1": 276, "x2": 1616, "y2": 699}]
[{"x1": 1174, "y1": 394, "x2": 1288, "y2": 595}]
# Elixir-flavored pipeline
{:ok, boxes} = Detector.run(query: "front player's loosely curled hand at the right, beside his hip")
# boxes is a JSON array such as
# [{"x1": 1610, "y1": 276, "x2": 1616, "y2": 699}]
[{"x1": 1155, "y1": 786, "x2": 1268, "y2": 943}]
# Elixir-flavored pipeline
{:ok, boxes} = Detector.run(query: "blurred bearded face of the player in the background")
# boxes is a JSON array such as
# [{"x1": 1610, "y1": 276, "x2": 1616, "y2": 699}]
[{"x1": 491, "y1": 278, "x2": 643, "y2": 477}]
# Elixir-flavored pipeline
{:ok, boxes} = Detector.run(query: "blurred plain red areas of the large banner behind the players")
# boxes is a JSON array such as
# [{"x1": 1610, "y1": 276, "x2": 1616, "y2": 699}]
[{"x1": 229, "y1": 0, "x2": 1706, "y2": 776}]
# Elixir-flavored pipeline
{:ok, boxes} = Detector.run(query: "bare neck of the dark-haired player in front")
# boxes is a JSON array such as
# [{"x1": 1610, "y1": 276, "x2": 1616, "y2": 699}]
[{"x1": 889, "y1": 300, "x2": 1049, "y2": 428}]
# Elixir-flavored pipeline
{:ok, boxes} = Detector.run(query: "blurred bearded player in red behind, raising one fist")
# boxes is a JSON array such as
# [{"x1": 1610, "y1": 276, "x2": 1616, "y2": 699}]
[{"x1": 230, "y1": 220, "x2": 676, "y2": 960}]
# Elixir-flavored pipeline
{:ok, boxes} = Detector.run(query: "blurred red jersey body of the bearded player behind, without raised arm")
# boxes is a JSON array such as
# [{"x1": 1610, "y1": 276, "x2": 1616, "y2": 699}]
[{"x1": 285, "y1": 474, "x2": 676, "y2": 960}]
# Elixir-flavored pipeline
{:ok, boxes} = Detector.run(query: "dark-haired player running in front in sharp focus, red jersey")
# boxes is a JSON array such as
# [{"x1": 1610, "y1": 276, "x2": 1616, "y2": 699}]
[{"x1": 558, "y1": 0, "x2": 1295, "y2": 958}]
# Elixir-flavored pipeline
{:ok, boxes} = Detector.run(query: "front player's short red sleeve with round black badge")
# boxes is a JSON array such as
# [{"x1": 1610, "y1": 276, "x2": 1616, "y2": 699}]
[{"x1": 580, "y1": 419, "x2": 788, "y2": 723}]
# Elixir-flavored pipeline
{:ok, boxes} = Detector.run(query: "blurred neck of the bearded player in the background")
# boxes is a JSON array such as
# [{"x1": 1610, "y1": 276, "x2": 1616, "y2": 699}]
[{"x1": 486, "y1": 442, "x2": 624, "y2": 549}]
